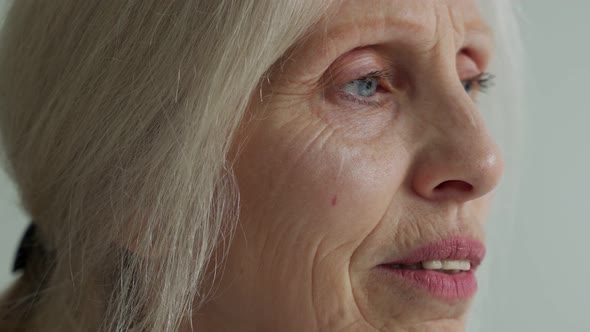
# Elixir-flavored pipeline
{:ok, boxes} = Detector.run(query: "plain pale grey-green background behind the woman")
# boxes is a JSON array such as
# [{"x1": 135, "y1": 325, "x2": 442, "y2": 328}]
[{"x1": 0, "y1": 0, "x2": 590, "y2": 332}]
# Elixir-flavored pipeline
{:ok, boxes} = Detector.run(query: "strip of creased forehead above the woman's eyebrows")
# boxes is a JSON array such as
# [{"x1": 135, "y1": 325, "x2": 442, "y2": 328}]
[{"x1": 324, "y1": 0, "x2": 492, "y2": 52}]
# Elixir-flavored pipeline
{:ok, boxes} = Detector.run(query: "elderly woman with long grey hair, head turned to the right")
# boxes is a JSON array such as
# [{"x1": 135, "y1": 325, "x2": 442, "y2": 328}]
[{"x1": 0, "y1": 0, "x2": 520, "y2": 331}]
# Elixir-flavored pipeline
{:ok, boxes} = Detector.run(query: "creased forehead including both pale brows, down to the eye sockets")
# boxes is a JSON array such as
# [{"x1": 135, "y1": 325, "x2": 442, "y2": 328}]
[{"x1": 280, "y1": 0, "x2": 494, "y2": 80}]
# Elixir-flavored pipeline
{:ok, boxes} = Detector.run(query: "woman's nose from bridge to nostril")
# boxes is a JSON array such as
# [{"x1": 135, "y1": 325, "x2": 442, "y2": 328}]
[{"x1": 411, "y1": 91, "x2": 504, "y2": 203}]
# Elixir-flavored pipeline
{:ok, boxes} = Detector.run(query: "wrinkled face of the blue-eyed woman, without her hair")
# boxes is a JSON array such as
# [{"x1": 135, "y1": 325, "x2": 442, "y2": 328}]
[{"x1": 196, "y1": 0, "x2": 502, "y2": 331}]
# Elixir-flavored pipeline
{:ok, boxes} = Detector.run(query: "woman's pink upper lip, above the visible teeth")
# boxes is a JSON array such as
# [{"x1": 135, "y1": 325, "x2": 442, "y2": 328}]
[{"x1": 383, "y1": 237, "x2": 486, "y2": 269}]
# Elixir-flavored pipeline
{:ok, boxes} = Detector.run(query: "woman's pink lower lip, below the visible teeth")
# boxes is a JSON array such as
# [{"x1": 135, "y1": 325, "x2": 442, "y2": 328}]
[{"x1": 381, "y1": 266, "x2": 477, "y2": 301}]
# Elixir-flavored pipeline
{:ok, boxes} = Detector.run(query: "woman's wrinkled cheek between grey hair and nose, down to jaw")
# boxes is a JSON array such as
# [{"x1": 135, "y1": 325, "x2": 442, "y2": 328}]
[{"x1": 220, "y1": 96, "x2": 416, "y2": 330}]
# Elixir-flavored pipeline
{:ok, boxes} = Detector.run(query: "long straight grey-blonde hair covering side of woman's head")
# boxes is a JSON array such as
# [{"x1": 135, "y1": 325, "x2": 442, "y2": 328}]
[{"x1": 0, "y1": 0, "x2": 524, "y2": 331}]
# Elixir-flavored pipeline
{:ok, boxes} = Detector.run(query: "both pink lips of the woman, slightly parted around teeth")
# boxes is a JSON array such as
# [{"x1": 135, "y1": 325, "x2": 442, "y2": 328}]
[{"x1": 378, "y1": 238, "x2": 486, "y2": 301}]
